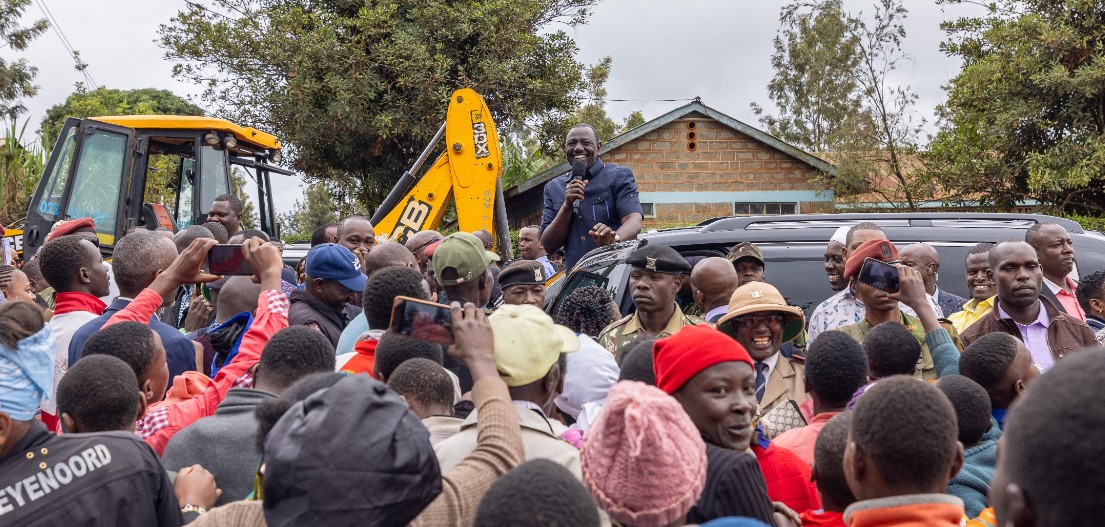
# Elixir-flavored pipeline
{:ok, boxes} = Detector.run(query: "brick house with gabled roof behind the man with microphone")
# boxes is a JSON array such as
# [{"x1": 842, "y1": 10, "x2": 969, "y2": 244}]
[{"x1": 504, "y1": 99, "x2": 833, "y2": 229}]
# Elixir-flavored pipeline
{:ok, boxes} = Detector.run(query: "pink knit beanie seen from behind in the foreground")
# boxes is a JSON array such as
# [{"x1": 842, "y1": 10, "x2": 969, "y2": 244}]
[{"x1": 580, "y1": 381, "x2": 706, "y2": 527}]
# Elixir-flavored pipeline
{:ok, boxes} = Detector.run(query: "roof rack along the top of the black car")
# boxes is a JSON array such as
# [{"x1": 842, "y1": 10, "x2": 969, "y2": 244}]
[{"x1": 698, "y1": 212, "x2": 1085, "y2": 234}]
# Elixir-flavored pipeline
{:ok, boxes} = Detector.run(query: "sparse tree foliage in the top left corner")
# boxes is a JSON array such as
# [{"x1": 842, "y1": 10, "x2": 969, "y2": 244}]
[{"x1": 0, "y1": 0, "x2": 50, "y2": 119}]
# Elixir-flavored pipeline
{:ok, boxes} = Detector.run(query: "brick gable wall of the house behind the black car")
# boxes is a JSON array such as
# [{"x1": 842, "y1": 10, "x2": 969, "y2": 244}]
[{"x1": 602, "y1": 114, "x2": 832, "y2": 226}]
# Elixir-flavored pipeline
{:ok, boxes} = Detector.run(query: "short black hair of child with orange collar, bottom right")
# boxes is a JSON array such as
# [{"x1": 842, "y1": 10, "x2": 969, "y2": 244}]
[{"x1": 851, "y1": 376, "x2": 958, "y2": 493}]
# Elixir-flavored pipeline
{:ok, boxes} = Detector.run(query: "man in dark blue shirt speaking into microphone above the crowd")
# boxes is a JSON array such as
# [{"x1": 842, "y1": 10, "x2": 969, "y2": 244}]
[{"x1": 541, "y1": 124, "x2": 644, "y2": 271}]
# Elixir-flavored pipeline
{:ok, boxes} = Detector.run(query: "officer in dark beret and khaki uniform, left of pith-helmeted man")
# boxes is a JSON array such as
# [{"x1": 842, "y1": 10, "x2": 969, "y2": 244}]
[{"x1": 599, "y1": 245, "x2": 706, "y2": 363}]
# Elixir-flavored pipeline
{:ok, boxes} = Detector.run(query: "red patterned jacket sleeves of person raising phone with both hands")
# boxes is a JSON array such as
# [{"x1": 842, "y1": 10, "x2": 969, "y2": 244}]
[{"x1": 104, "y1": 289, "x2": 288, "y2": 455}]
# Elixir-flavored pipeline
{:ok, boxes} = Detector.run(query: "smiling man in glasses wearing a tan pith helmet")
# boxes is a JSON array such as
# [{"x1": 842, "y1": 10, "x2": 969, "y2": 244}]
[{"x1": 717, "y1": 282, "x2": 809, "y2": 415}]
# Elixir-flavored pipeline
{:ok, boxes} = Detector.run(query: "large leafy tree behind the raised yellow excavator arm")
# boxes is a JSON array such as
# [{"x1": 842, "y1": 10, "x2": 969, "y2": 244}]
[{"x1": 159, "y1": 0, "x2": 597, "y2": 212}]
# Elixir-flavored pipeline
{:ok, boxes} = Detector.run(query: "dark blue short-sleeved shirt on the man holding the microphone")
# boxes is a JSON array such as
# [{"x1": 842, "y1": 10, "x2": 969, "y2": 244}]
[{"x1": 541, "y1": 159, "x2": 643, "y2": 271}]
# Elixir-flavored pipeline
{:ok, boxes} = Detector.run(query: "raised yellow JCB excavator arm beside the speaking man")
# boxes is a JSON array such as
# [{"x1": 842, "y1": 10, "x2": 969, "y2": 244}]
[{"x1": 372, "y1": 88, "x2": 511, "y2": 257}]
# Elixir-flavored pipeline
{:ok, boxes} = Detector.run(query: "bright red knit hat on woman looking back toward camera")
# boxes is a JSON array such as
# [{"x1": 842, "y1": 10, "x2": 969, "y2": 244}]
[{"x1": 652, "y1": 326, "x2": 753, "y2": 393}]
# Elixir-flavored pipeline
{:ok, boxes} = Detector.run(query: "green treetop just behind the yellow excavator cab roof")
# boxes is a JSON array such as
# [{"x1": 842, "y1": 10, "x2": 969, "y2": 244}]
[{"x1": 39, "y1": 87, "x2": 203, "y2": 145}]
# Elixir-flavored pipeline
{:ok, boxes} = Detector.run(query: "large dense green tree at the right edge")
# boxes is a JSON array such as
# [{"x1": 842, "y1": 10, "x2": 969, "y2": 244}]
[{"x1": 926, "y1": 0, "x2": 1105, "y2": 213}]
